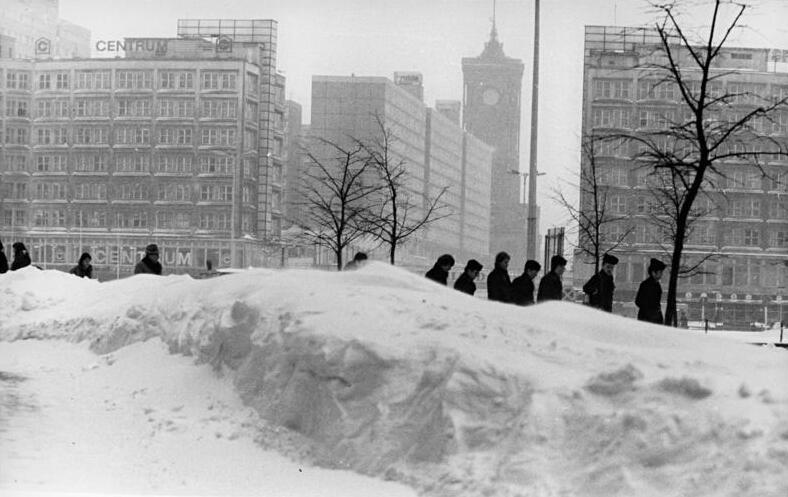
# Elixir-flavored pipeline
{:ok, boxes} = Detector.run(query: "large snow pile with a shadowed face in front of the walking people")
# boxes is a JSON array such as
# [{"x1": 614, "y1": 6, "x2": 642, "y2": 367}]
[{"x1": 0, "y1": 264, "x2": 788, "y2": 497}]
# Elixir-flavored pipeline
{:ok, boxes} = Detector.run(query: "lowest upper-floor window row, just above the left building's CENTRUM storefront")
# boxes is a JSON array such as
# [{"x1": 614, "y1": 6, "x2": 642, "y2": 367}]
[{"x1": 3, "y1": 208, "x2": 231, "y2": 231}]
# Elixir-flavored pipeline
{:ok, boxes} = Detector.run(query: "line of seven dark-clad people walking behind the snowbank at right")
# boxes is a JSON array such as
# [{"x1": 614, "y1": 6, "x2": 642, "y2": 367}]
[{"x1": 418, "y1": 252, "x2": 665, "y2": 324}]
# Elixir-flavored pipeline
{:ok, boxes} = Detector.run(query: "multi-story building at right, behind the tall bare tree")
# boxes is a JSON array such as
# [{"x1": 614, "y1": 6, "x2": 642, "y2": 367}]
[{"x1": 574, "y1": 26, "x2": 788, "y2": 326}]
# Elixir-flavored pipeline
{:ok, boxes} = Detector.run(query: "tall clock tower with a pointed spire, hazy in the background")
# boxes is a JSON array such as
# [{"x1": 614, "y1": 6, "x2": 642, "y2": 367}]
[{"x1": 462, "y1": 19, "x2": 527, "y2": 264}]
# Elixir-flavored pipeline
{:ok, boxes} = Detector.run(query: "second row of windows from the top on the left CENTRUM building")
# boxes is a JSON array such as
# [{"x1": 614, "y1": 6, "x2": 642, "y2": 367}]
[{"x1": 5, "y1": 98, "x2": 243, "y2": 119}]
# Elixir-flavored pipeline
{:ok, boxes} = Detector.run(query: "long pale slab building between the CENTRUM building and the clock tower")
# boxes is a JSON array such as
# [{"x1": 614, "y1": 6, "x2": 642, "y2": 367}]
[{"x1": 310, "y1": 76, "x2": 493, "y2": 267}]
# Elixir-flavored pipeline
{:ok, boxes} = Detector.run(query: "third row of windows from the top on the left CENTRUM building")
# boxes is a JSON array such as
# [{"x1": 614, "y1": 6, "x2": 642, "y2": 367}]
[{"x1": 5, "y1": 126, "x2": 239, "y2": 145}]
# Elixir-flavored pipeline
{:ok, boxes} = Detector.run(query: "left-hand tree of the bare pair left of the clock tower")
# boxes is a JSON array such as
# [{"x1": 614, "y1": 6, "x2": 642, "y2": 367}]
[{"x1": 303, "y1": 139, "x2": 381, "y2": 270}]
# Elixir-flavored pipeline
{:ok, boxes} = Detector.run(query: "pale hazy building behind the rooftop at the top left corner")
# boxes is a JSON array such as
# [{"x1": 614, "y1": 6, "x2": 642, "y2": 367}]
[{"x1": 0, "y1": 0, "x2": 90, "y2": 59}]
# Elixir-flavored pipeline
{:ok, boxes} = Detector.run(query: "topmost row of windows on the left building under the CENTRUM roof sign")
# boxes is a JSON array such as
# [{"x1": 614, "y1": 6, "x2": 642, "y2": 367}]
[{"x1": 5, "y1": 69, "x2": 242, "y2": 90}]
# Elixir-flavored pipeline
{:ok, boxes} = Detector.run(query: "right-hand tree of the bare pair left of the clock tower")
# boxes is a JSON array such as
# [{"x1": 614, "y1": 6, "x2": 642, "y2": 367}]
[{"x1": 355, "y1": 114, "x2": 448, "y2": 264}]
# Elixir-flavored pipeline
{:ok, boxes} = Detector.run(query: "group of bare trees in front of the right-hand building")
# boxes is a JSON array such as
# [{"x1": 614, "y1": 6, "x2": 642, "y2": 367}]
[{"x1": 557, "y1": 0, "x2": 788, "y2": 326}]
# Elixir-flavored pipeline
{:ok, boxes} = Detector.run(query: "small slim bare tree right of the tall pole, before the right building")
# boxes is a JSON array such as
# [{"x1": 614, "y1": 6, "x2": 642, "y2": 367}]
[{"x1": 554, "y1": 133, "x2": 634, "y2": 274}]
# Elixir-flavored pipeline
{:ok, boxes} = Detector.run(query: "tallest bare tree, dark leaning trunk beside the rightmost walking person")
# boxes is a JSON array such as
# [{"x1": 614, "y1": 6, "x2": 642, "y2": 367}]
[{"x1": 628, "y1": 0, "x2": 788, "y2": 325}]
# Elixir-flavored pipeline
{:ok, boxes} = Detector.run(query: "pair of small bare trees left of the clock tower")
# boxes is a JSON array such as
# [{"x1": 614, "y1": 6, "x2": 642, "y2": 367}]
[{"x1": 301, "y1": 114, "x2": 448, "y2": 269}]
